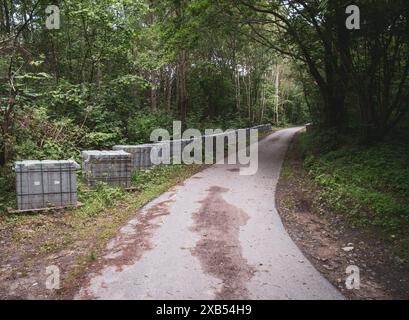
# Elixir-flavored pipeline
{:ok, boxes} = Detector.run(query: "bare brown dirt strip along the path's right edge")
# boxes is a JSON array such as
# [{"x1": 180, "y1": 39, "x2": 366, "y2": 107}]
[{"x1": 276, "y1": 133, "x2": 409, "y2": 300}]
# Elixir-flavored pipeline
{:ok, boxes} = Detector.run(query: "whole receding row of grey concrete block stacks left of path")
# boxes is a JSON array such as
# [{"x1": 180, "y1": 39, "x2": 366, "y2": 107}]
[{"x1": 11, "y1": 124, "x2": 278, "y2": 210}]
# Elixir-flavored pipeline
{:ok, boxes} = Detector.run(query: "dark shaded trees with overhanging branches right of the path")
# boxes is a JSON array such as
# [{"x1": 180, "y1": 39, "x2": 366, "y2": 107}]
[{"x1": 238, "y1": 0, "x2": 409, "y2": 135}]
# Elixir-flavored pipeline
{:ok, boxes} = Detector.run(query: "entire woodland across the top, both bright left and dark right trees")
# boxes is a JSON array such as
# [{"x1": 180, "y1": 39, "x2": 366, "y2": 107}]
[{"x1": 0, "y1": 0, "x2": 409, "y2": 195}]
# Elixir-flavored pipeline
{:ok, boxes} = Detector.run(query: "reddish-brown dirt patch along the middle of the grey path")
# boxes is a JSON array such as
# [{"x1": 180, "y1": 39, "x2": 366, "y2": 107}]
[{"x1": 191, "y1": 187, "x2": 256, "y2": 300}]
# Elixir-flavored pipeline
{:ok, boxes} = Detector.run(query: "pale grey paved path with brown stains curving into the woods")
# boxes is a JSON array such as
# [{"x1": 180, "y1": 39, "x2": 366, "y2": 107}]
[{"x1": 76, "y1": 128, "x2": 343, "y2": 300}]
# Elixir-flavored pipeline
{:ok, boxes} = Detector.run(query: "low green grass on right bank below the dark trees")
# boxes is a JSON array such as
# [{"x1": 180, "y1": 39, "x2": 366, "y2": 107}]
[{"x1": 300, "y1": 133, "x2": 409, "y2": 260}]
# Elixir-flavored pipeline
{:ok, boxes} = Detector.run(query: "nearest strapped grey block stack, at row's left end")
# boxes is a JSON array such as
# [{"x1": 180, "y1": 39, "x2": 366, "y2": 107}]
[{"x1": 14, "y1": 160, "x2": 79, "y2": 210}]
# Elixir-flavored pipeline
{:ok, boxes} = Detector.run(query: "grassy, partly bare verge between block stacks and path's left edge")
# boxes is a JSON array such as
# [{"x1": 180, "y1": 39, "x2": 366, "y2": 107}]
[{"x1": 0, "y1": 165, "x2": 204, "y2": 298}]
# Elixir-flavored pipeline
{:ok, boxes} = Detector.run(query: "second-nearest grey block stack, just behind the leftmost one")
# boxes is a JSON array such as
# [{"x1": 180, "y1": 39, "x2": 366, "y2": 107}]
[{"x1": 81, "y1": 150, "x2": 132, "y2": 188}]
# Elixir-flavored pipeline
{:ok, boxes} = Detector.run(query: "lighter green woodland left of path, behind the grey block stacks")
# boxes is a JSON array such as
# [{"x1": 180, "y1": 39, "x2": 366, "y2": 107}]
[{"x1": 0, "y1": 0, "x2": 307, "y2": 165}]
